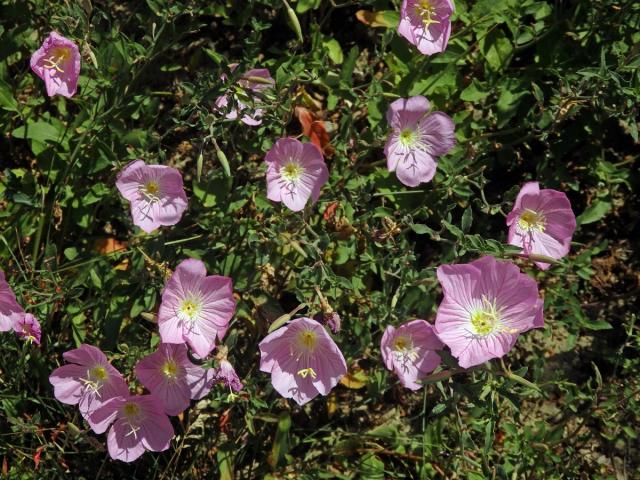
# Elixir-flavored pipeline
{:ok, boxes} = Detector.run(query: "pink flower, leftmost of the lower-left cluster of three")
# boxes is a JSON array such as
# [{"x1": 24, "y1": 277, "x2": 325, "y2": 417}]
[{"x1": 49, "y1": 344, "x2": 129, "y2": 427}]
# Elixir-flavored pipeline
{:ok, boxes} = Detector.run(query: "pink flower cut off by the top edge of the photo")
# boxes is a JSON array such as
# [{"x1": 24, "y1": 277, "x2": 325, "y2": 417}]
[{"x1": 398, "y1": 0, "x2": 455, "y2": 55}]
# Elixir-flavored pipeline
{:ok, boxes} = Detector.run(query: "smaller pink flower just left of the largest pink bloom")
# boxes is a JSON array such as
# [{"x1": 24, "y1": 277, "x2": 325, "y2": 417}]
[{"x1": 380, "y1": 320, "x2": 443, "y2": 390}]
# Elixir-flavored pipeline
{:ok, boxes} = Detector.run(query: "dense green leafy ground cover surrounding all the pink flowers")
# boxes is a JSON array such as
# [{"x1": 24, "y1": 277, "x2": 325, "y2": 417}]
[{"x1": 0, "y1": 0, "x2": 640, "y2": 479}]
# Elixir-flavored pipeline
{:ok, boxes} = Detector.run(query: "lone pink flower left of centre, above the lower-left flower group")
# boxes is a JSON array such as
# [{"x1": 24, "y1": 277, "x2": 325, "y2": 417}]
[{"x1": 116, "y1": 160, "x2": 187, "y2": 233}]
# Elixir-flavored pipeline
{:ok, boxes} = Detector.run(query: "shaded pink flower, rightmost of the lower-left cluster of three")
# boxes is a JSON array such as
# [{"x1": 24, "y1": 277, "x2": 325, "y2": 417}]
[{"x1": 134, "y1": 343, "x2": 213, "y2": 415}]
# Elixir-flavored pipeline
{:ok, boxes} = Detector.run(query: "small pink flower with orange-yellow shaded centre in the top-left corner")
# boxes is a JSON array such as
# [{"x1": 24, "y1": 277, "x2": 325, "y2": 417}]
[{"x1": 31, "y1": 32, "x2": 80, "y2": 98}]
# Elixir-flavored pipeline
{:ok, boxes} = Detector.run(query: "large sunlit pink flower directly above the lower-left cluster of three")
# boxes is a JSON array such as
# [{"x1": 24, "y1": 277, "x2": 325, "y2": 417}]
[{"x1": 158, "y1": 259, "x2": 236, "y2": 358}]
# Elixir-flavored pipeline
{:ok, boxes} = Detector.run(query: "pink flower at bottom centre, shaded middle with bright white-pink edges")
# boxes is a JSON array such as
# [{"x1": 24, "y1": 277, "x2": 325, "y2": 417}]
[{"x1": 259, "y1": 317, "x2": 347, "y2": 405}]
